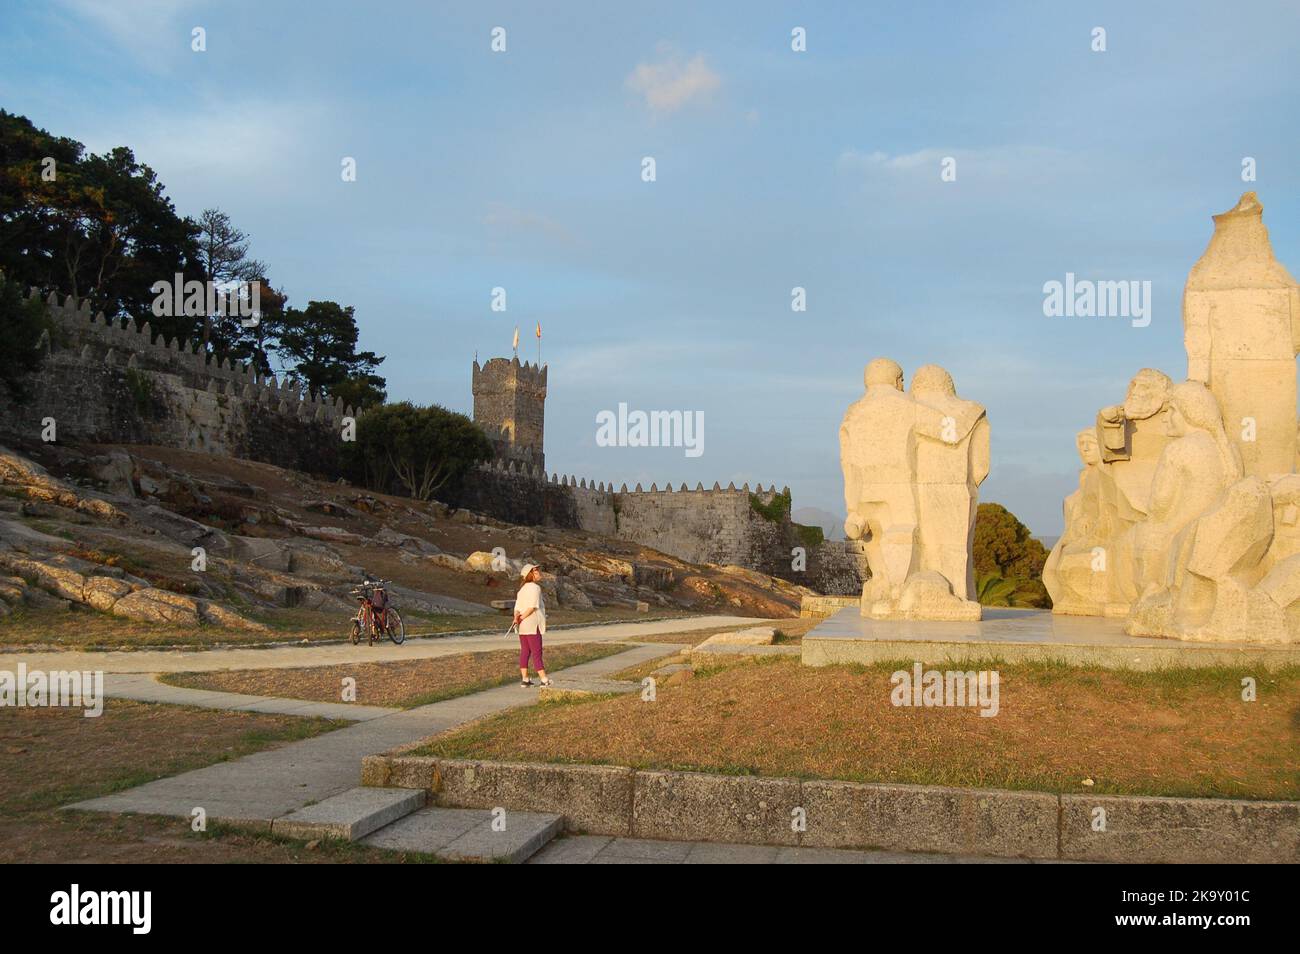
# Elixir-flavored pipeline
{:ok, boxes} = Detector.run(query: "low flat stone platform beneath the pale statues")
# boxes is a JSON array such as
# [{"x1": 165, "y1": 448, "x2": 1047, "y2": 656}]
[{"x1": 802, "y1": 607, "x2": 1300, "y2": 669}]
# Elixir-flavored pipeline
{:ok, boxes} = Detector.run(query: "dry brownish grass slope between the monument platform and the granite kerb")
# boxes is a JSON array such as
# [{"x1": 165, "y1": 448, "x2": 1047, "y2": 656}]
[{"x1": 419, "y1": 656, "x2": 1300, "y2": 799}]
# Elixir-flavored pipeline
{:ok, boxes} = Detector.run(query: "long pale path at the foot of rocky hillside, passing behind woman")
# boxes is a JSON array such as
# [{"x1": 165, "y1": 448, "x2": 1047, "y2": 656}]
[{"x1": 0, "y1": 616, "x2": 757, "y2": 672}]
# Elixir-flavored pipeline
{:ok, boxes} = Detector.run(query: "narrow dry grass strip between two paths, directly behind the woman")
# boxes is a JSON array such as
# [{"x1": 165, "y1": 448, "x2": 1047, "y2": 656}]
[{"x1": 163, "y1": 642, "x2": 628, "y2": 708}]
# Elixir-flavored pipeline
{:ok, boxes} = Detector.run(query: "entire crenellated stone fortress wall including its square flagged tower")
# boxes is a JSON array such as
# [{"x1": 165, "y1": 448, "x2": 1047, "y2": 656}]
[{"x1": 0, "y1": 291, "x2": 866, "y2": 593}]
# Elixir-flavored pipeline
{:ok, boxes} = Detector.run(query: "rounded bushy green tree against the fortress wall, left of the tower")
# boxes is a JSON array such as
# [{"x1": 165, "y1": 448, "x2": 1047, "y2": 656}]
[{"x1": 356, "y1": 402, "x2": 493, "y2": 500}]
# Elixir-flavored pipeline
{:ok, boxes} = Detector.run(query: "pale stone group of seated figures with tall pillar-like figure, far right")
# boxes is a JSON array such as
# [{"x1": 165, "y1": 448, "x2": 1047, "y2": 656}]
[{"x1": 1043, "y1": 192, "x2": 1300, "y2": 642}]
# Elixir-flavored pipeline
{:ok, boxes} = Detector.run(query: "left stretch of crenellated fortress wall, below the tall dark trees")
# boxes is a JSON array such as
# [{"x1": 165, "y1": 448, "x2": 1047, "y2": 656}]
[{"x1": 0, "y1": 291, "x2": 356, "y2": 473}]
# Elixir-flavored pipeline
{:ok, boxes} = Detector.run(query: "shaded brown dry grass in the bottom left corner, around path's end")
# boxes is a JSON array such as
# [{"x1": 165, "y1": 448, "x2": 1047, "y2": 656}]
[{"x1": 0, "y1": 699, "x2": 441, "y2": 864}]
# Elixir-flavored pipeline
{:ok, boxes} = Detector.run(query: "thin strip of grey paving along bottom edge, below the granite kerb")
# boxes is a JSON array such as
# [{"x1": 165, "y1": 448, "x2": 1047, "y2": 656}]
[{"x1": 528, "y1": 834, "x2": 1031, "y2": 864}]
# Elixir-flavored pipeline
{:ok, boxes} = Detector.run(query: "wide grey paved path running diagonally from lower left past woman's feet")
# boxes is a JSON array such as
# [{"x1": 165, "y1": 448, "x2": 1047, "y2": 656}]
[{"x1": 68, "y1": 645, "x2": 677, "y2": 825}]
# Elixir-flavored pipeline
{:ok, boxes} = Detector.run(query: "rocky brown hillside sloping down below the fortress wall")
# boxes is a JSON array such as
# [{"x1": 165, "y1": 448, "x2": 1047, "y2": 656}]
[{"x1": 0, "y1": 445, "x2": 807, "y2": 643}]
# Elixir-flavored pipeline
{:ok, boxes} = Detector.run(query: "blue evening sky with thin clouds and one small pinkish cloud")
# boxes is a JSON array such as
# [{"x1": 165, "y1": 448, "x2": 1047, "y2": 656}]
[{"x1": 0, "y1": 0, "x2": 1300, "y2": 535}]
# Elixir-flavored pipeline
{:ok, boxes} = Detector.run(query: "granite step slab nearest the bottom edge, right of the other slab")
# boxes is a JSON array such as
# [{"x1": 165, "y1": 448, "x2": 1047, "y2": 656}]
[{"x1": 361, "y1": 808, "x2": 564, "y2": 864}]
